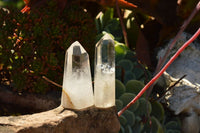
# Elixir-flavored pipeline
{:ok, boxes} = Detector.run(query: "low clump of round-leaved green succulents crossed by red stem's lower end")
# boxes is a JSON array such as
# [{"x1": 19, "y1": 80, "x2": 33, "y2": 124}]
[{"x1": 116, "y1": 79, "x2": 180, "y2": 133}]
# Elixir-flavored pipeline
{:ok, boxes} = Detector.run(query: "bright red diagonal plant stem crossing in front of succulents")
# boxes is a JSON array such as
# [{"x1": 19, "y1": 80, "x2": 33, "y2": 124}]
[{"x1": 118, "y1": 28, "x2": 200, "y2": 116}]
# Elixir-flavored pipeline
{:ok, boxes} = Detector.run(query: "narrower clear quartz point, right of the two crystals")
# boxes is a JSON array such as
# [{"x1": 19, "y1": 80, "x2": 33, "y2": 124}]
[{"x1": 94, "y1": 34, "x2": 115, "y2": 108}]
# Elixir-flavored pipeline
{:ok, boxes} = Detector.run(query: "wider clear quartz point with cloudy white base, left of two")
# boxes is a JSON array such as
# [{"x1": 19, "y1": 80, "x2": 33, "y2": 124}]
[{"x1": 61, "y1": 41, "x2": 94, "y2": 109}]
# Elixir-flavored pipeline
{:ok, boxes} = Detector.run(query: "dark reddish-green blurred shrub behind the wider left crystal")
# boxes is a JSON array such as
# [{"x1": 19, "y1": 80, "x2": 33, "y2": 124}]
[{"x1": 0, "y1": 1, "x2": 96, "y2": 93}]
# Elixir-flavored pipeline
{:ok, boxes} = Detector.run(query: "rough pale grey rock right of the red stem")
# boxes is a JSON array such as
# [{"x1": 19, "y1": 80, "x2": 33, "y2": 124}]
[{"x1": 158, "y1": 33, "x2": 200, "y2": 133}]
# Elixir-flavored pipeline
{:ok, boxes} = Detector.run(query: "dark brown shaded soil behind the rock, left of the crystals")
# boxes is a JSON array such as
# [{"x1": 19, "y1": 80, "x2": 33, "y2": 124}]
[{"x1": 0, "y1": 85, "x2": 61, "y2": 116}]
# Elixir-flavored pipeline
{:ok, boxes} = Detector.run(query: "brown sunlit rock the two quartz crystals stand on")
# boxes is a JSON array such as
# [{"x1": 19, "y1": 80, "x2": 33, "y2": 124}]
[{"x1": 0, "y1": 106, "x2": 120, "y2": 133}]
